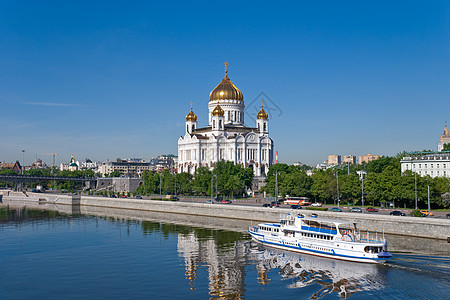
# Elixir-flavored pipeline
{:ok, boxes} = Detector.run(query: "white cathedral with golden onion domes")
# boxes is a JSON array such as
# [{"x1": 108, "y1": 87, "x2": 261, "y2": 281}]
[{"x1": 178, "y1": 63, "x2": 273, "y2": 177}]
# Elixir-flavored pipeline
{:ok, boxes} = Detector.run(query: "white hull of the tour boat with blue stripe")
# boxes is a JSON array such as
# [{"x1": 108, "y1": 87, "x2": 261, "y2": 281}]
[{"x1": 248, "y1": 230, "x2": 390, "y2": 264}]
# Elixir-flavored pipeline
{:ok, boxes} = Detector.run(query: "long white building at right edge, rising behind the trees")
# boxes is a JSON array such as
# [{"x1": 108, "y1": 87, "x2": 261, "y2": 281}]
[{"x1": 400, "y1": 153, "x2": 450, "y2": 177}]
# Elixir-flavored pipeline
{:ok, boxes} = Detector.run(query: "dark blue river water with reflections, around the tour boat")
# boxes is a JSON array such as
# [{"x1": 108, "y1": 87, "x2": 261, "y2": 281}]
[{"x1": 0, "y1": 206, "x2": 450, "y2": 299}]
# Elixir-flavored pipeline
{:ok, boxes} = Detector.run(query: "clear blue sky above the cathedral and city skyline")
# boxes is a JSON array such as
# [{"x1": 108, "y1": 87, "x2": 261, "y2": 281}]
[{"x1": 0, "y1": 0, "x2": 450, "y2": 164}]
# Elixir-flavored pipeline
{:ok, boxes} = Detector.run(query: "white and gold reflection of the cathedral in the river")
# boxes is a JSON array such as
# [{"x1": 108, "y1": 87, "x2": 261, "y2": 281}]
[{"x1": 178, "y1": 233, "x2": 245, "y2": 299}]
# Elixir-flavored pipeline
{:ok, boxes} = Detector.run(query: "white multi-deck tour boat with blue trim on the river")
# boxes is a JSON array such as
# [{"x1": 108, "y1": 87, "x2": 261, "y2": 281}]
[{"x1": 248, "y1": 214, "x2": 392, "y2": 263}]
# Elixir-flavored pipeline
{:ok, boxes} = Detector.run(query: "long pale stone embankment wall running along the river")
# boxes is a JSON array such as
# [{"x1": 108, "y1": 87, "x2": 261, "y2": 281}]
[{"x1": 3, "y1": 193, "x2": 450, "y2": 241}]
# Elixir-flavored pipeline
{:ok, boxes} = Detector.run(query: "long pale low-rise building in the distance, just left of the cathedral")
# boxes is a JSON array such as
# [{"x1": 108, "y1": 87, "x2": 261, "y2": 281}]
[{"x1": 98, "y1": 158, "x2": 153, "y2": 177}]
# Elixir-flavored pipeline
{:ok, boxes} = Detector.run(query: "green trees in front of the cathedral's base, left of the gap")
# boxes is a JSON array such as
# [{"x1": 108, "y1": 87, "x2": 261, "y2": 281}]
[{"x1": 136, "y1": 161, "x2": 253, "y2": 197}]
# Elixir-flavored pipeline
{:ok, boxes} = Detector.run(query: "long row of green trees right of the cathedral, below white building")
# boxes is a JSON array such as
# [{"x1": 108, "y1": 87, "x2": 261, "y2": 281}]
[{"x1": 263, "y1": 153, "x2": 450, "y2": 208}]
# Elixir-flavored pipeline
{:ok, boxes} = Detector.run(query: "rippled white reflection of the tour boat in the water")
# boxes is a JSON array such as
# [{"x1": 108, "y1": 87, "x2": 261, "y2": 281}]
[{"x1": 249, "y1": 243, "x2": 384, "y2": 299}]
